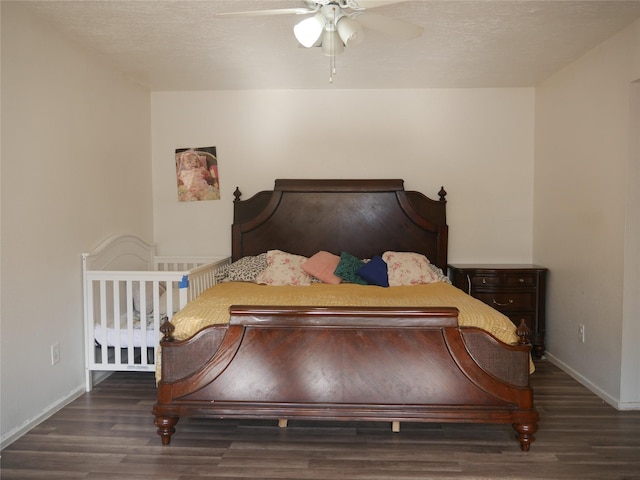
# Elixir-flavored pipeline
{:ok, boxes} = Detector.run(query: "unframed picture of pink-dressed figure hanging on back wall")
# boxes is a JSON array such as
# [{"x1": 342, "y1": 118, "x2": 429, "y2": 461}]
[{"x1": 176, "y1": 147, "x2": 220, "y2": 202}]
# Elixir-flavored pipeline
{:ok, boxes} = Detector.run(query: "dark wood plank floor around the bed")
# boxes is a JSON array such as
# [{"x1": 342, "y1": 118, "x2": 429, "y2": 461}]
[{"x1": 0, "y1": 361, "x2": 640, "y2": 480}]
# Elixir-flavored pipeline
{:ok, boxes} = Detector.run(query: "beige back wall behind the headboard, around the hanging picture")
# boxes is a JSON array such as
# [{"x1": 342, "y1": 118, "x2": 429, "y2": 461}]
[{"x1": 151, "y1": 88, "x2": 534, "y2": 262}]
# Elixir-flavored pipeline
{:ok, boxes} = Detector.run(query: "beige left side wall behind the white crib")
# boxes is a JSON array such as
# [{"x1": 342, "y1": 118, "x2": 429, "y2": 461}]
[{"x1": 0, "y1": 2, "x2": 152, "y2": 442}]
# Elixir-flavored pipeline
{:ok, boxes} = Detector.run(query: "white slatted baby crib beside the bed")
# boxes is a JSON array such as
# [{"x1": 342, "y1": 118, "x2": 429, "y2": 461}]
[{"x1": 82, "y1": 235, "x2": 229, "y2": 391}]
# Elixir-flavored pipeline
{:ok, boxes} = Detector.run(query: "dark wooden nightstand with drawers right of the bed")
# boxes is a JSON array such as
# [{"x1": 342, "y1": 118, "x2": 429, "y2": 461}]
[{"x1": 449, "y1": 264, "x2": 547, "y2": 358}]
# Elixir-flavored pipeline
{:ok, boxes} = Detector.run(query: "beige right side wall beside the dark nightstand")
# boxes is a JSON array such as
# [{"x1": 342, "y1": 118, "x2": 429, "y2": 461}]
[{"x1": 533, "y1": 17, "x2": 640, "y2": 408}]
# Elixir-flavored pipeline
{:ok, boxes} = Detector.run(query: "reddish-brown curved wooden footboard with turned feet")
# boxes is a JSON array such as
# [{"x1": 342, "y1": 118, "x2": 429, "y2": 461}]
[{"x1": 153, "y1": 306, "x2": 538, "y2": 450}]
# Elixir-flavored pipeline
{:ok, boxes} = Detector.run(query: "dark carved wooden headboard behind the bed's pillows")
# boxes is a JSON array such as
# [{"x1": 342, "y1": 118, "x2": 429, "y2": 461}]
[{"x1": 232, "y1": 179, "x2": 448, "y2": 271}]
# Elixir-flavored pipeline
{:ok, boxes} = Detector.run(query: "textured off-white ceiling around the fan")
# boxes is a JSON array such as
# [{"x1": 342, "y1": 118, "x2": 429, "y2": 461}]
[{"x1": 17, "y1": 0, "x2": 640, "y2": 91}]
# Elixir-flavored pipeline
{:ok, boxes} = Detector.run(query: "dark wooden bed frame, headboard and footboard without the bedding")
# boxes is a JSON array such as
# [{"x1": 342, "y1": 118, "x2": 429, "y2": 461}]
[{"x1": 153, "y1": 180, "x2": 538, "y2": 451}]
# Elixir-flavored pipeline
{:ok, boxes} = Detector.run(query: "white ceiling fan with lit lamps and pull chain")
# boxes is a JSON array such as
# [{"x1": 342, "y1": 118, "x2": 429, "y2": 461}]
[{"x1": 216, "y1": 0, "x2": 424, "y2": 82}]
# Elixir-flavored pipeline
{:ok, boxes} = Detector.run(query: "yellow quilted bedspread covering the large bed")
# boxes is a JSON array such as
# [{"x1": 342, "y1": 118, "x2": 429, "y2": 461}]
[{"x1": 171, "y1": 282, "x2": 518, "y2": 343}]
